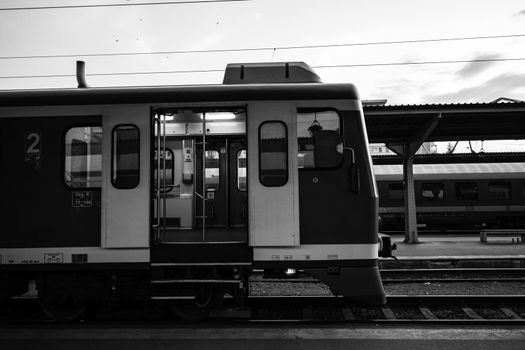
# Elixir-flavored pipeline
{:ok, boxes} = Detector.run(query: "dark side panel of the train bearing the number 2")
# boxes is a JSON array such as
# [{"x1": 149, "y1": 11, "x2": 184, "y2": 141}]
[{"x1": 0, "y1": 116, "x2": 102, "y2": 248}]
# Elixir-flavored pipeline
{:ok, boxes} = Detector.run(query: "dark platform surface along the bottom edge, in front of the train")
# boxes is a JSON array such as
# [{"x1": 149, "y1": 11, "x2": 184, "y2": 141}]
[{"x1": 0, "y1": 324, "x2": 525, "y2": 350}]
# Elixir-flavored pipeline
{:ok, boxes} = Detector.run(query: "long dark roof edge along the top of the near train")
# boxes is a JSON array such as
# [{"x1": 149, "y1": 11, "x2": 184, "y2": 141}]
[{"x1": 0, "y1": 83, "x2": 359, "y2": 107}]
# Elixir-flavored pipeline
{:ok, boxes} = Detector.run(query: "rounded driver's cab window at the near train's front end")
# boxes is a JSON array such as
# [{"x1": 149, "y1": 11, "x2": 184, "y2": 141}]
[{"x1": 297, "y1": 110, "x2": 343, "y2": 168}]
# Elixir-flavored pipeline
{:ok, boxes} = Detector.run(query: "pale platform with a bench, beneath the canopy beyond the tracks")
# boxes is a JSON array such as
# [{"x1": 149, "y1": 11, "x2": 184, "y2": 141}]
[{"x1": 380, "y1": 234, "x2": 525, "y2": 267}]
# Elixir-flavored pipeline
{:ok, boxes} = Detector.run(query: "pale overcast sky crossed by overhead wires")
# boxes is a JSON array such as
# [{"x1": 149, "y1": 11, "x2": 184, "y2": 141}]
[{"x1": 0, "y1": 0, "x2": 525, "y2": 104}]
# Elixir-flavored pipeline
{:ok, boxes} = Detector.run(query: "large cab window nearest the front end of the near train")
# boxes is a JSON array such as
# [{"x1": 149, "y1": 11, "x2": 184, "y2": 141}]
[{"x1": 297, "y1": 110, "x2": 343, "y2": 168}]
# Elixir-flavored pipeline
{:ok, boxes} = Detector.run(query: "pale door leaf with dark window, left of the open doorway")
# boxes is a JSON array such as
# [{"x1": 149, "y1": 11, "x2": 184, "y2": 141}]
[{"x1": 102, "y1": 106, "x2": 151, "y2": 248}]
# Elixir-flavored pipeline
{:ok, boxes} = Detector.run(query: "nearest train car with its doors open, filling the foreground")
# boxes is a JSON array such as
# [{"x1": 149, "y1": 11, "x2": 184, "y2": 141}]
[{"x1": 0, "y1": 63, "x2": 386, "y2": 319}]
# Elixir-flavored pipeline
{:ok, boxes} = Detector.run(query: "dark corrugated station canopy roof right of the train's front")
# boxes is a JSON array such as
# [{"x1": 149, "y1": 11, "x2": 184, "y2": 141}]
[{"x1": 363, "y1": 101, "x2": 525, "y2": 144}]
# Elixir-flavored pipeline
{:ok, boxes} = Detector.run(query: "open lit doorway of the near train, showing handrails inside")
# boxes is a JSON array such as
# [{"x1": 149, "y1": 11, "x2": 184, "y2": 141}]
[{"x1": 152, "y1": 109, "x2": 248, "y2": 244}]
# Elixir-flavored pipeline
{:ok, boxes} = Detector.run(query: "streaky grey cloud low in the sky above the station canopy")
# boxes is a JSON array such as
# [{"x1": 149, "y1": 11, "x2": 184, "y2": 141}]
[{"x1": 425, "y1": 73, "x2": 525, "y2": 103}]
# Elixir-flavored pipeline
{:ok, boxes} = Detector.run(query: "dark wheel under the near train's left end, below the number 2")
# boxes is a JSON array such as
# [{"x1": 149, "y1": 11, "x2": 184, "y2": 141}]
[{"x1": 38, "y1": 275, "x2": 87, "y2": 322}]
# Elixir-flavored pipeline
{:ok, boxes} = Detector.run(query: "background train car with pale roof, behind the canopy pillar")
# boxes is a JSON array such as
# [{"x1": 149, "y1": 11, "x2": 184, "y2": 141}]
[{"x1": 374, "y1": 163, "x2": 525, "y2": 232}]
